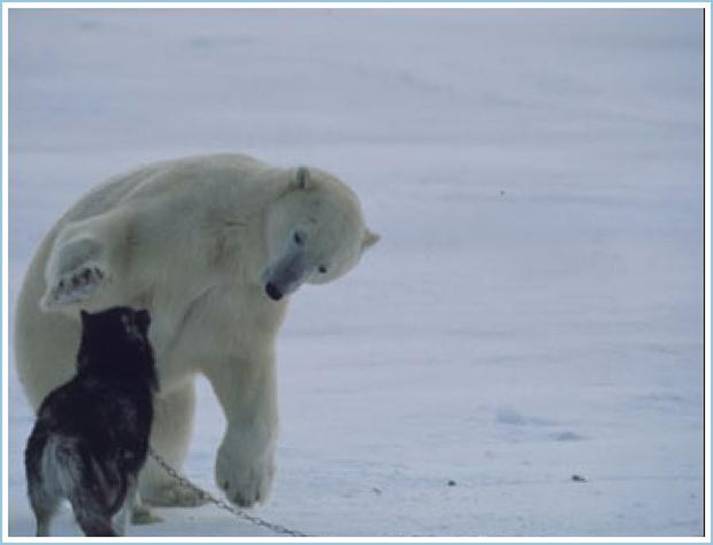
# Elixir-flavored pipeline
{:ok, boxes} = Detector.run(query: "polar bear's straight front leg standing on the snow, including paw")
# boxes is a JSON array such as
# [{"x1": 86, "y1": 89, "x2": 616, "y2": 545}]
[{"x1": 206, "y1": 357, "x2": 277, "y2": 507}]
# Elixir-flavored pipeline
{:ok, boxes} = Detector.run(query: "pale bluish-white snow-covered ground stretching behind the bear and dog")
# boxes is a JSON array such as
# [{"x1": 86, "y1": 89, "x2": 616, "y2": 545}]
[{"x1": 9, "y1": 9, "x2": 703, "y2": 536}]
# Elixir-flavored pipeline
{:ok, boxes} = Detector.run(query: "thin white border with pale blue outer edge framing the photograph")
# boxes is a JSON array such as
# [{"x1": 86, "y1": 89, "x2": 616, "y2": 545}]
[{"x1": 0, "y1": 0, "x2": 712, "y2": 543}]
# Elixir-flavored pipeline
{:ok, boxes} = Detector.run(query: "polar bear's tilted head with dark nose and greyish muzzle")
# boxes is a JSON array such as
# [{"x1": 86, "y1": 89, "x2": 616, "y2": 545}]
[{"x1": 262, "y1": 167, "x2": 379, "y2": 301}]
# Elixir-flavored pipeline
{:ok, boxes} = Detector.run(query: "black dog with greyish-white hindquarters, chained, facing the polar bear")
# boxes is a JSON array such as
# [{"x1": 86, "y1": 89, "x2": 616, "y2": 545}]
[{"x1": 25, "y1": 307, "x2": 158, "y2": 536}]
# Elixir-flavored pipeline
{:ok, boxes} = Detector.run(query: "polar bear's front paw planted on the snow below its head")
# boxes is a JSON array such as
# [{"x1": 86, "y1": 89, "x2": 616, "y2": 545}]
[{"x1": 215, "y1": 447, "x2": 275, "y2": 507}]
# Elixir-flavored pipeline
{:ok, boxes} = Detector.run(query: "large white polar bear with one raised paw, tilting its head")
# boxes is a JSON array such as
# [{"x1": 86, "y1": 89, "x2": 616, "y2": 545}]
[{"x1": 15, "y1": 154, "x2": 378, "y2": 506}]
